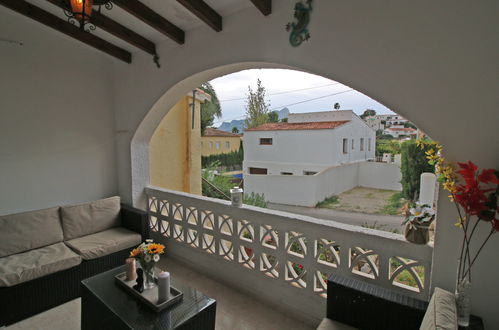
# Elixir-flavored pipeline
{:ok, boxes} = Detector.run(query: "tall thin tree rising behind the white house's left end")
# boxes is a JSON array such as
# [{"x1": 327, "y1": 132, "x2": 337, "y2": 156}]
[{"x1": 245, "y1": 79, "x2": 270, "y2": 128}]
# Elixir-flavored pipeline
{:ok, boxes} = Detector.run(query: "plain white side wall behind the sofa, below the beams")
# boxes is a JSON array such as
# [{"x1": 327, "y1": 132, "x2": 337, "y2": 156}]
[{"x1": 0, "y1": 6, "x2": 118, "y2": 214}]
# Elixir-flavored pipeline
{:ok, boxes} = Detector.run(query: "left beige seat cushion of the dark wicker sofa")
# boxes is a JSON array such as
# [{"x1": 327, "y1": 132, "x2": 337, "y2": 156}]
[{"x1": 0, "y1": 242, "x2": 81, "y2": 287}]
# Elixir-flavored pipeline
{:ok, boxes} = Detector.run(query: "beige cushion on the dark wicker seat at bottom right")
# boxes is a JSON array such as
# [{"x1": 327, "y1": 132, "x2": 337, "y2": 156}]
[{"x1": 419, "y1": 288, "x2": 457, "y2": 330}]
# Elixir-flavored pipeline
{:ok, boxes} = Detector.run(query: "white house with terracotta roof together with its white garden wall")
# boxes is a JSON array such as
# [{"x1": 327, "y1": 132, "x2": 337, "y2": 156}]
[{"x1": 243, "y1": 110, "x2": 400, "y2": 206}]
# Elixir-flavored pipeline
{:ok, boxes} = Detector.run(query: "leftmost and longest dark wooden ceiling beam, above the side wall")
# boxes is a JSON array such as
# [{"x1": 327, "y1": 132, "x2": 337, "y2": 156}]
[{"x1": 0, "y1": 0, "x2": 132, "y2": 63}]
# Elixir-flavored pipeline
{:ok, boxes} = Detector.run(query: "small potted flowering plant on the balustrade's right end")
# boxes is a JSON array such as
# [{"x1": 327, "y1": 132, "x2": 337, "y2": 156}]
[{"x1": 402, "y1": 202, "x2": 435, "y2": 244}]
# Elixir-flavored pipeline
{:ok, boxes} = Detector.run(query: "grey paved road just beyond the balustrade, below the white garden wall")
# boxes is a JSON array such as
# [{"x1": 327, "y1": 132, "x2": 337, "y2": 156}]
[{"x1": 268, "y1": 203, "x2": 404, "y2": 234}]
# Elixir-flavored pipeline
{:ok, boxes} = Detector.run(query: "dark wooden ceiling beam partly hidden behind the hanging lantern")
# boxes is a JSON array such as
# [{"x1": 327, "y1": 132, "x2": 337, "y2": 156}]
[{"x1": 47, "y1": 0, "x2": 156, "y2": 55}]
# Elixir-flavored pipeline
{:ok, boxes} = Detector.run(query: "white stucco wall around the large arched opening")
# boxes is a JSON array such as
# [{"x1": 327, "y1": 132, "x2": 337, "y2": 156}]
[{"x1": 114, "y1": 0, "x2": 499, "y2": 328}]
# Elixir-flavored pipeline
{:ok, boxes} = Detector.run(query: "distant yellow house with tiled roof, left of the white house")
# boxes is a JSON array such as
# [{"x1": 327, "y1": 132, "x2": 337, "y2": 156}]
[{"x1": 201, "y1": 127, "x2": 242, "y2": 156}]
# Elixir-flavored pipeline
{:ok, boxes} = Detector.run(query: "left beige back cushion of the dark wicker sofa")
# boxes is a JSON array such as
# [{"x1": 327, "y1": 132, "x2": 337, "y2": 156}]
[{"x1": 0, "y1": 207, "x2": 62, "y2": 257}]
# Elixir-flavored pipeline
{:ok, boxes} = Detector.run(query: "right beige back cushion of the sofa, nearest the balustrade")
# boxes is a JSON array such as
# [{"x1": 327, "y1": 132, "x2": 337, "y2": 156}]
[{"x1": 61, "y1": 196, "x2": 120, "y2": 240}]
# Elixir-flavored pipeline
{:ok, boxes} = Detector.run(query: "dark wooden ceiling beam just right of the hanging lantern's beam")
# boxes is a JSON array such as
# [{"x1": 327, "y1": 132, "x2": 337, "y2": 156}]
[{"x1": 113, "y1": 0, "x2": 185, "y2": 44}]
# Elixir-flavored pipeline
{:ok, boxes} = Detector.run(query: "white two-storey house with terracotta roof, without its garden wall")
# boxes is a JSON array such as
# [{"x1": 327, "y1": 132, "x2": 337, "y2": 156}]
[{"x1": 243, "y1": 110, "x2": 376, "y2": 175}]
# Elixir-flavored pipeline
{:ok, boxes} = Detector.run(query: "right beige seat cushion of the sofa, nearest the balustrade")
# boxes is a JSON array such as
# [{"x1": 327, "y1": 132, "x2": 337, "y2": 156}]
[{"x1": 65, "y1": 227, "x2": 141, "y2": 260}]
